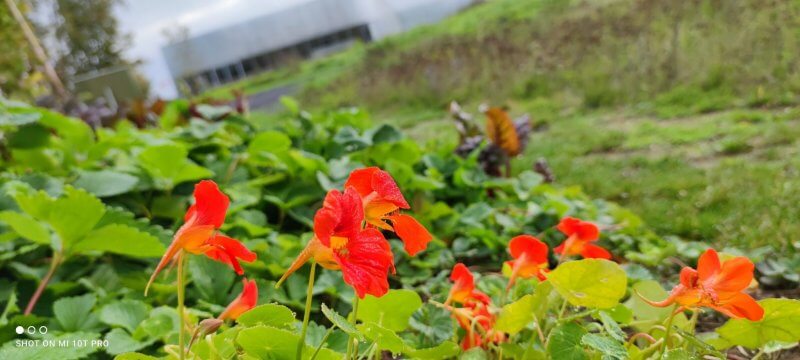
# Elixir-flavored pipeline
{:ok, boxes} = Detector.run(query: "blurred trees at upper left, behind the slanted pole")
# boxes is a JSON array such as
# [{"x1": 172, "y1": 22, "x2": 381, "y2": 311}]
[{"x1": 0, "y1": 0, "x2": 132, "y2": 100}]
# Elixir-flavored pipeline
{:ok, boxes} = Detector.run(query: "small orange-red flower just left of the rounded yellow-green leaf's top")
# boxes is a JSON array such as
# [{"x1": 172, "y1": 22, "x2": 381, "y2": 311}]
[{"x1": 506, "y1": 235, "x2": 548, "y2": 288}]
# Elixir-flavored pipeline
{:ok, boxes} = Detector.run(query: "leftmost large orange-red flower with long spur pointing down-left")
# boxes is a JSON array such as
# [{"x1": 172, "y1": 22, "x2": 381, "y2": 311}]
[{"x1": 145, "y1": 180, "x2": 256, "y2": 294}]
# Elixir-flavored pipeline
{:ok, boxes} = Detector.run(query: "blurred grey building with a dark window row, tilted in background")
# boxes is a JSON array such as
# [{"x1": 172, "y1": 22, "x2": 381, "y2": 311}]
[{"x1": 161, "y1": 0, "x2": 473, "y2": 92}]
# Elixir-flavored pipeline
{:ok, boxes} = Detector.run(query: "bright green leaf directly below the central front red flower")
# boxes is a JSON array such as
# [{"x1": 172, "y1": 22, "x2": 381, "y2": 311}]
[{"x1": 358, "y1": 290, "x2": 422, "y2": 331}]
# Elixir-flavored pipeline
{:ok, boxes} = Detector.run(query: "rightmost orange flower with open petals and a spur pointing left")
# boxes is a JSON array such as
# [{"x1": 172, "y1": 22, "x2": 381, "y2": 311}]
[{"x1": 644, "y1": 249, "x2": 764, "y2": 321}]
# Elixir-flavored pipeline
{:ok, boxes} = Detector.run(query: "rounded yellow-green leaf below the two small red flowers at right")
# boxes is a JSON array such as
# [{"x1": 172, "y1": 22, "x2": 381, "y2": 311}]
[{"x1": 547, "y1": 259, "x2": 627, "y2": 309}]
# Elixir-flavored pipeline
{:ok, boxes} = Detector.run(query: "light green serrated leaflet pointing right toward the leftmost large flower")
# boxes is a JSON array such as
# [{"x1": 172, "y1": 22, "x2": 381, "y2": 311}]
[{"x1": 72, "y1": 224, "x2": 166, "y2": 257}]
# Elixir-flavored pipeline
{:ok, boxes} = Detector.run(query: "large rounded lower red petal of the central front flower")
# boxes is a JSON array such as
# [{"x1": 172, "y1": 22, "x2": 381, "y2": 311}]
[{"x1": 334, "y1": 229, "x2": 394, "y2": 299}]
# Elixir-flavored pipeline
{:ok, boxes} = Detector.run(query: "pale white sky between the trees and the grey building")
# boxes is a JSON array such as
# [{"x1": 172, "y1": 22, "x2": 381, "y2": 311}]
[{"x1": 117, "y1": 0, "x2": 309, "y2": 98}]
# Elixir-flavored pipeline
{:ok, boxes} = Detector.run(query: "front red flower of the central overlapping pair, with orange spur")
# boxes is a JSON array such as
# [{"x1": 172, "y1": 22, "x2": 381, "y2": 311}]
[{"x1": 278, "y1": 188, "x2": 394, "y2": 298}]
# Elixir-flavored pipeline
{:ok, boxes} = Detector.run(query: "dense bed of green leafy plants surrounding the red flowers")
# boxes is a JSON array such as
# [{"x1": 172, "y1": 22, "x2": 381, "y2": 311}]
[{"x1": 0, "y1": 99, "x2": 800, "y2": 359}]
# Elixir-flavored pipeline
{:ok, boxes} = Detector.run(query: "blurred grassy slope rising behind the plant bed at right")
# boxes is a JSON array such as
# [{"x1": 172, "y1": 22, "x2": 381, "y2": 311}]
[{"x1": 203, "y1": 0, "x2": 800, "y2": 251}]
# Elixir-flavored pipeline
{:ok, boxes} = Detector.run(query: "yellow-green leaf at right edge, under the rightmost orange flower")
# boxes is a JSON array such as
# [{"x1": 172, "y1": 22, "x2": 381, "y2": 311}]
[{"x1": 717, "y1": 299, "x2": 800, "y2": 349}]
